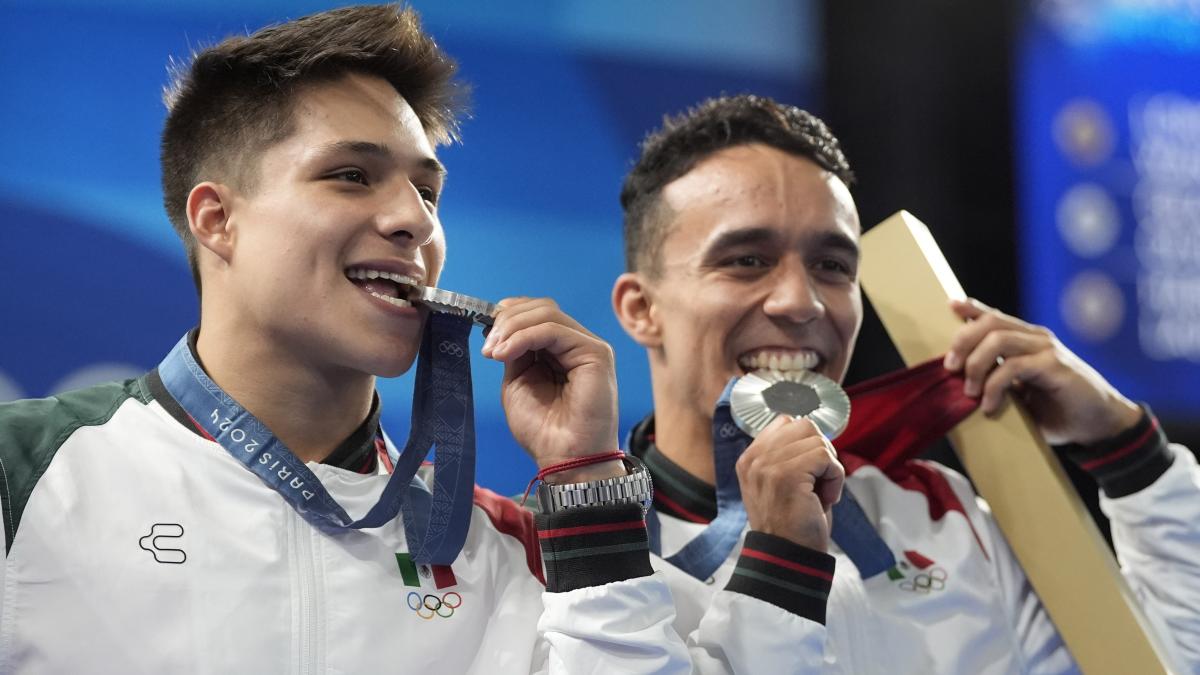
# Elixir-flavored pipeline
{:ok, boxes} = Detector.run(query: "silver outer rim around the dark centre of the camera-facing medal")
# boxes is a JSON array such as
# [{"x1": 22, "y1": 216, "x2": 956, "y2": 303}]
[{"x1": 730, "y1": 369, "x2": 850, "y2": 441}]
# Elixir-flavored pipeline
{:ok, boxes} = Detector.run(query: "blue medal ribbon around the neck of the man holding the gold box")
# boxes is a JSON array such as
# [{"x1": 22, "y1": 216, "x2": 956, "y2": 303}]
[{"x1": 646, "y1": 377, "x2": 895, "y2": 581}]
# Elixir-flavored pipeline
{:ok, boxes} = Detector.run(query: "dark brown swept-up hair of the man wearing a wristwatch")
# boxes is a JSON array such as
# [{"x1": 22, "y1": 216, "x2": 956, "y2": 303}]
[{"x1": 161, "y1": 5, "x2": 467, "y2": 293}]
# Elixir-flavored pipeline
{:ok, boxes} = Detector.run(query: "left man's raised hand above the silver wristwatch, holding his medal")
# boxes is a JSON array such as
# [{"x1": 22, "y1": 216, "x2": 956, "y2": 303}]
[{"x1": 482, "y1": 298, "x2": 625, "y2": 483}]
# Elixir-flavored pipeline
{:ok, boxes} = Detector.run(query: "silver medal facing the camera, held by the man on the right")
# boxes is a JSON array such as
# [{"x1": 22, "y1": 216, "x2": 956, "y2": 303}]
[{"x1": 730, "y1": 370, "x2": 850, "y2": 441}]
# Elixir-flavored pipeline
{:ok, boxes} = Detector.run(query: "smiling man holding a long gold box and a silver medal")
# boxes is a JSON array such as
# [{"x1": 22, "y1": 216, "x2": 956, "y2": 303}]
[{"x1": 613, "y1": 96, "x2": 1200, "y2": 674}]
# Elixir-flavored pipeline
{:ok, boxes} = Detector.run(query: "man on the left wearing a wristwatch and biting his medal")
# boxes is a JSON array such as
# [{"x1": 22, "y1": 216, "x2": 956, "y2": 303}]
[{"x1": 0, "y1": 6, "x2": 689, "y2": 673}]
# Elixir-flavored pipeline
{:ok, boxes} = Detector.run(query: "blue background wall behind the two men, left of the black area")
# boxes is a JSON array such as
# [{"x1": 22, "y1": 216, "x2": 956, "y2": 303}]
[{"x1": 0, "y1": 0, "x2": 820, "y2": 491}]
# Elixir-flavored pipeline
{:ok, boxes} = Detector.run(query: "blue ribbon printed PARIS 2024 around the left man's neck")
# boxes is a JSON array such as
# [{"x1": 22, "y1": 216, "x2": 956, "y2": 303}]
[{"x1": 158, "y1": 312, "x2": 475, "y2": 565}]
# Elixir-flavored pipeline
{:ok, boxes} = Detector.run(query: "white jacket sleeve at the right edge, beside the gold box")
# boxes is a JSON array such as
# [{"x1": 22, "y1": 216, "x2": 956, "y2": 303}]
[{"x1": 1100, "y1": 446, "x2": 1200, "y2": 673}]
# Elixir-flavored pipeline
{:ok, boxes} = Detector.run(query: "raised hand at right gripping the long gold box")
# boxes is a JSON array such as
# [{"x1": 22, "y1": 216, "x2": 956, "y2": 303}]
[{"x1": 943, "y1": 299, "x2": 1141, "y2": 444}]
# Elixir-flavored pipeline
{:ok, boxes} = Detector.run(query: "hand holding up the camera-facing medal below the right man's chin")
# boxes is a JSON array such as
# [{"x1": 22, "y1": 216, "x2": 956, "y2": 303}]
[{"x1": 738, "y1": 416, "x2": 846, "y2": 551}]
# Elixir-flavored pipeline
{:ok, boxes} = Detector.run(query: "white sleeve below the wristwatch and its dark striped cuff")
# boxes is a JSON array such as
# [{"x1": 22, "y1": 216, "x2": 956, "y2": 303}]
[{"x1": 538, "y1": 572, "x2": 691, "y2": 675}]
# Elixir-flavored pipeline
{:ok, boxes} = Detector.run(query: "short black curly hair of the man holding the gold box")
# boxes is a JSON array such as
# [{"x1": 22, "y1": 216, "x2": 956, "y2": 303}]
[{"x1": 620, "y1": 95, "x2": 854, "y2": 277}]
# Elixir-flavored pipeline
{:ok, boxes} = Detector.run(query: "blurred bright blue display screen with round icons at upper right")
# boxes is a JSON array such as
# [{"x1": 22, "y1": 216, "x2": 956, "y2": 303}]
[{"x1": 1015, "y1": 0, "x2": 1200, "y2": 419}]
